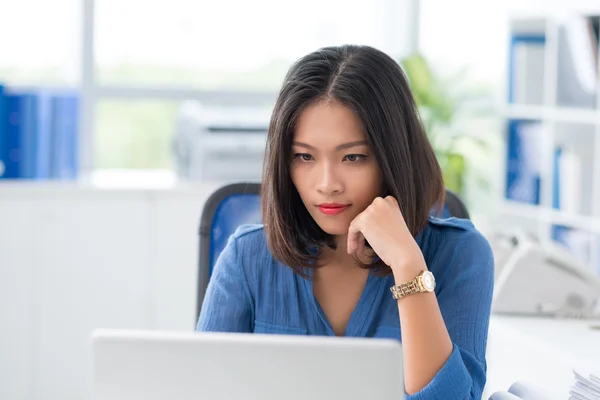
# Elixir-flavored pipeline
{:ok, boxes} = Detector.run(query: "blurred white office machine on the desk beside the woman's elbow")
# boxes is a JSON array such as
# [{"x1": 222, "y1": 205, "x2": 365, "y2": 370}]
[{"x1": 490, "y1": 229, "x2": 600, "y2": 319}]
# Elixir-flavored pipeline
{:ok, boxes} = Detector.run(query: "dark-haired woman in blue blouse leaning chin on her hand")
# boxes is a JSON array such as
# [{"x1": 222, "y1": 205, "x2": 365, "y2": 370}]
[{"x1": 198, "y1": 46, "x2": 493, "y2": 400}]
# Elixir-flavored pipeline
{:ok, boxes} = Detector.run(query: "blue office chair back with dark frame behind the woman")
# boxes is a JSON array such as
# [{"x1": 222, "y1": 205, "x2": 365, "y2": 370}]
[{"x1": 196, "y1": 183, "x2": 469, "y2": 317}]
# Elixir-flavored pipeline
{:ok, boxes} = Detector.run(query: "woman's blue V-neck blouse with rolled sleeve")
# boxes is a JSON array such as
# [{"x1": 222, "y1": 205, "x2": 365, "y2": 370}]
[{"x1": 197, "y1": 217, "x2": 494, "y2": 400}]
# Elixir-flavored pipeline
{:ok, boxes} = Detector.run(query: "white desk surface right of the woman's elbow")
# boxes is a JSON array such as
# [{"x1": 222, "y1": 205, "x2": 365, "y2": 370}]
[{"x1": 486, "y1": 315, "x2": 600, "y2": 399}]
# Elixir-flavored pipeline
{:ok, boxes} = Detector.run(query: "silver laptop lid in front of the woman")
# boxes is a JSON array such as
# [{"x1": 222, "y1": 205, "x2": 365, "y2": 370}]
[{"x1": 92, "y1": 330, "x2": 405, "y2": 400}]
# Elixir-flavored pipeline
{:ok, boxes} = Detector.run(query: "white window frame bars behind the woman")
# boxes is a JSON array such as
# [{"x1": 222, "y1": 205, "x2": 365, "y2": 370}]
[{"x1": 79, "y1": 0, "x2": 420, "y2": 178}]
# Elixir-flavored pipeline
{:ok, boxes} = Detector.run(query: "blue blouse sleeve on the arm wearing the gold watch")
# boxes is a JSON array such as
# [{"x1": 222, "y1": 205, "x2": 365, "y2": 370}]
[{"x1": 407, "y1": 231, "x2": 494, "y2": 400}]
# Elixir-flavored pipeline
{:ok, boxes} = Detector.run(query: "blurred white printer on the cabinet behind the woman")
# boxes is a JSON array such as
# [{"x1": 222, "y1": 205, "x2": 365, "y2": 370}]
[{"x1": 173, "y1": 101, "x2": 272, "y2": 181}]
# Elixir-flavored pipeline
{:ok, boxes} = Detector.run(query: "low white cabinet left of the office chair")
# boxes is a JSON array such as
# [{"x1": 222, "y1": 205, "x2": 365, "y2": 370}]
[{"x1": 0, "y1": 183, "x2": 218, "y2": 400}]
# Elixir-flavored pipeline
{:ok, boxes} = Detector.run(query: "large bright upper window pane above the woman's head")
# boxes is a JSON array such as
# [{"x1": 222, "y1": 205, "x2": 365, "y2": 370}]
[{"x1": 96, "y1": 0, "x2": 412, "y2": 90}]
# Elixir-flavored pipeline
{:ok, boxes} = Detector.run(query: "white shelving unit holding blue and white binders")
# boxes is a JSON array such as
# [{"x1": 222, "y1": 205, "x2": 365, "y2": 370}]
[{"x1": 501, "y1": 11, "x2": 600, "y2": 274}]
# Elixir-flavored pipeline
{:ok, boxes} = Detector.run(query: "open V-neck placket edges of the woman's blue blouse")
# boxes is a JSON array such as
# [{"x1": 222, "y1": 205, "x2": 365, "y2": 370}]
[{"x1": 302, "y1": 268, "x2": 381, "y2": 337}]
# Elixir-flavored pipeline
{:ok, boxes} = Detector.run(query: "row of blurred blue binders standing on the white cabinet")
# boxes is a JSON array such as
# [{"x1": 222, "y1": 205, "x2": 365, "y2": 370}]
[{"x1": 0, "y1": 85, "x2": 79, "y2": 180}]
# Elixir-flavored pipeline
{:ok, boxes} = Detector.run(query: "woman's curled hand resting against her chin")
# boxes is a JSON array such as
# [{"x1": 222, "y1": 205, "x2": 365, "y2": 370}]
[{"x1": 348, "y1": 196, "x2": 426, "y2": 279}]
